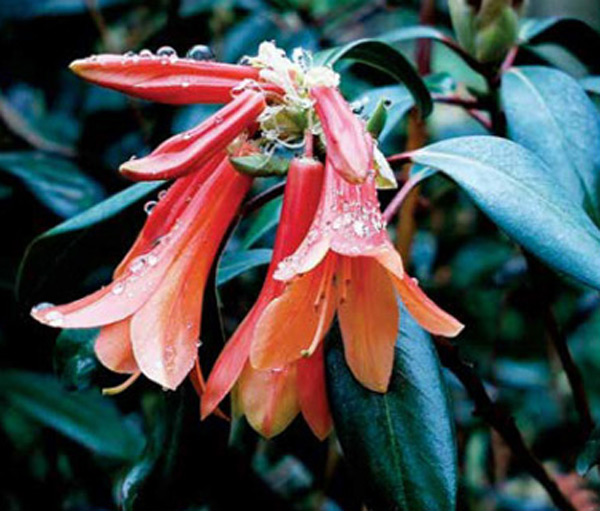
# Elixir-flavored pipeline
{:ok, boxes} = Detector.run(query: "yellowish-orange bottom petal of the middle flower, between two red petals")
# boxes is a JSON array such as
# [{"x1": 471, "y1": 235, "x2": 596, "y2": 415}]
[{"x1": 236, "y1": 364, "x2": 300, "y2": 438}]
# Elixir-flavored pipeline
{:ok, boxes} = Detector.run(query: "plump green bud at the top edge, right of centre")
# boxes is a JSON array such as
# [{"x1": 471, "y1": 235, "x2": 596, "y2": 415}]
[{"x1": 449, "y1": 0, "x2": 526, "y2": 63}]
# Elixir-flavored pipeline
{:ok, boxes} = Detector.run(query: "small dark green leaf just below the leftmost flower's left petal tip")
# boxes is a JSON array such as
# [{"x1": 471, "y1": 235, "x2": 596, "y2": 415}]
[{"x1": 54, "y1": 329, "x2": 99, "y2": 389}]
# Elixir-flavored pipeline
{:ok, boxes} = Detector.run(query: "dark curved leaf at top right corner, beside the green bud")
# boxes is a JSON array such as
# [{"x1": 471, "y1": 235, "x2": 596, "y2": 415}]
[{"x1": 519, "y1": 17, "x2": 600, "y2": 73}]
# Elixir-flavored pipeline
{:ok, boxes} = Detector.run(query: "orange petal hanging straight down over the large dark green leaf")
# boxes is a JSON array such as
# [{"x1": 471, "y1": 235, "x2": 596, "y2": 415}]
[{"x1": 338, "y1": 257, "x2": 399, "y2": 392}]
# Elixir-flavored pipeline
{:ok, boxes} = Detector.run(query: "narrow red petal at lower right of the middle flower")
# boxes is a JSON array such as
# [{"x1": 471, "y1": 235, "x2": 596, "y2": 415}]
[{"x1": 297, "y1": 343, "x2": 333, "y2": 440}]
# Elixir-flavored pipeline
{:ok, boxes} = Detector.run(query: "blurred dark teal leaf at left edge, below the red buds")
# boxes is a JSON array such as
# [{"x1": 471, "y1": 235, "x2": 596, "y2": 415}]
[{"x1": 0, "y1": 151, "x2": 104, "y2": 218}]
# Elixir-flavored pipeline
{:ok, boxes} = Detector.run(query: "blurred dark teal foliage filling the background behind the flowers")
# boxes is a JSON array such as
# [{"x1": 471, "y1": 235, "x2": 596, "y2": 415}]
[{"x1": 0, "y1": 0, "x2": 600, "y2": 511}]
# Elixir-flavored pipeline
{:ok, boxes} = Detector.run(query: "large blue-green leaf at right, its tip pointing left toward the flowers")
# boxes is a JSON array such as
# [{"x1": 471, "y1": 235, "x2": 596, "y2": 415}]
[{"x1": 411, "y1": 136, "x2": 600, "y2": 288}]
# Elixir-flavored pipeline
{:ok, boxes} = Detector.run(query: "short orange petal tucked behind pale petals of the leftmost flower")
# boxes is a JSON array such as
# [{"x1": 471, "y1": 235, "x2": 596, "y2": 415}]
[{"x1": 94, "y1": 318, "x2": 139, "y2": 374}]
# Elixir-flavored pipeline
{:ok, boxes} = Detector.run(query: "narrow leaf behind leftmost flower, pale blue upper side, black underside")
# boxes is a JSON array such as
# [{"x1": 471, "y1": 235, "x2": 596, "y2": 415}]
[{"x1": 16, "y1": 181, "x2": 163, "y2": 299}]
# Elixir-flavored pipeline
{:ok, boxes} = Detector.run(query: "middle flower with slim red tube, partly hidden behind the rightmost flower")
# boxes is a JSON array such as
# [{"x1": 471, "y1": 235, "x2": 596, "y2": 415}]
[{"x1": 202, "y1": 159, "x2": 331, "y2": 438}]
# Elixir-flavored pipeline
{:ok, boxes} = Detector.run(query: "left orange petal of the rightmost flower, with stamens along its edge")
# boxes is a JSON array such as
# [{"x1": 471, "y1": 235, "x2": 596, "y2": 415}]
[{"x1": 250, "y1": 254, "x2": 337, "y2": 369}]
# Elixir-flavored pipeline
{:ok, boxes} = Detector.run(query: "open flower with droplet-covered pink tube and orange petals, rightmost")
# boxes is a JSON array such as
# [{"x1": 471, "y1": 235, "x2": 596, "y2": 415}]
[{"x1": 250, "y1": 161, "x2": 463, "y2": 392}]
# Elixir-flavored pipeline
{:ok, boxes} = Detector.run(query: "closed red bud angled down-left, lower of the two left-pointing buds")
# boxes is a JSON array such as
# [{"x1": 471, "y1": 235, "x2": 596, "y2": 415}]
[{"x1": 119, "y1": 90, "x2": 266, "y2": 181}]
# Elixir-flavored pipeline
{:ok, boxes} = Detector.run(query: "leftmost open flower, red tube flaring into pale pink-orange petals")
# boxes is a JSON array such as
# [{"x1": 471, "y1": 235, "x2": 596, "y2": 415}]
[{"x1": 32, "y1": 158, "x2": 252, "y2": 389}]
